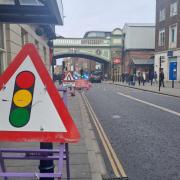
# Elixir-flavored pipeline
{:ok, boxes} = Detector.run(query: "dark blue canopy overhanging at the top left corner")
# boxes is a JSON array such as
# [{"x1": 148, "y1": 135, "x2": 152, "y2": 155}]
[{"x1": 0, "y1": 0, "x2": 63, "y2": 25}]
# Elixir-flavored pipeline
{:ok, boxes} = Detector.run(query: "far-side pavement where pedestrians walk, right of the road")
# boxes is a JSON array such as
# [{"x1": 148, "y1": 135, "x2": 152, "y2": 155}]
[{"x1": 106, "y1": 81, "x2": 180, "y2": 97}]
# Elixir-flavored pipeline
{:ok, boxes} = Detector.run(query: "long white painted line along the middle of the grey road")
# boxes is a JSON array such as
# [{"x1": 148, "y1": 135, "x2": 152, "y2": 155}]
[{"x1": 117, "y1": 92, "x2": 180, "y2": 117}]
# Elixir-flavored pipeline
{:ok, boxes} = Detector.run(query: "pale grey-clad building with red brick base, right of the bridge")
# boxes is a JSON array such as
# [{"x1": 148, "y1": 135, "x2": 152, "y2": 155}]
[{"x1": 123, "y1": 23, "x2": 155, "y2": 74}]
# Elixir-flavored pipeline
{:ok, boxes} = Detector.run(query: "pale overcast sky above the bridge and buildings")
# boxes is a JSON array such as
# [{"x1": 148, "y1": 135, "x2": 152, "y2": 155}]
[{"x1": 56, "y1": 0, "x2": 156, "y2": 37}]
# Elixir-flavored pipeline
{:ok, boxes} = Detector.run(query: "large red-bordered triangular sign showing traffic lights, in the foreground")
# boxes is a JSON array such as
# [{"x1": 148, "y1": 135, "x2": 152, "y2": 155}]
[{"x1": 0, "y1": 44, "x2": 80, "y2": 143}]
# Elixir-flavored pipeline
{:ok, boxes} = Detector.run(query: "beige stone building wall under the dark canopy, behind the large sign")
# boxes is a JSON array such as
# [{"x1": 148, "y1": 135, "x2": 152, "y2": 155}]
[{"x1": 0, "y1": 24, "x2": 51, "y2": 73}]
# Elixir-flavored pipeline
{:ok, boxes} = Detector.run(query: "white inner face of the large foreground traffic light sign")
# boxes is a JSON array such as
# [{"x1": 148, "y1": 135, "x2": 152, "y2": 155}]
[{"x1": 0, "y1": 56, "x2": 67, "y2": 132}]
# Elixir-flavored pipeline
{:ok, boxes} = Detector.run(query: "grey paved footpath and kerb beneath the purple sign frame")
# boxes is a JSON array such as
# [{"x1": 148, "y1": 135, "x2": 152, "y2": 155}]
[{"x1": 0, "y1": 92, "x2": 107, "y2": 180}]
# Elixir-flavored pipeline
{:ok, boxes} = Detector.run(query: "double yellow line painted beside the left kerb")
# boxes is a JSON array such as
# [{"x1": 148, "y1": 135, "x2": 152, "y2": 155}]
[{"x1": 82, "y1": 93, "x2": 127, "y2": 177}]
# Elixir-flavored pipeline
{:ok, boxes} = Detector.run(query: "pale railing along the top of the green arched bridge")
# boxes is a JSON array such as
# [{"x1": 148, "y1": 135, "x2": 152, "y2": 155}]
[{"x1": 53, "y1": 38, "x2": 110, "y2": 47}]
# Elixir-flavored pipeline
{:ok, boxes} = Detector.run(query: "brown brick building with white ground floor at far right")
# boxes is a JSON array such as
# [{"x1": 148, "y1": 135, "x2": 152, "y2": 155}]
[{"x1": 155, "y1": 0, "x2": 180, "y2": 81}]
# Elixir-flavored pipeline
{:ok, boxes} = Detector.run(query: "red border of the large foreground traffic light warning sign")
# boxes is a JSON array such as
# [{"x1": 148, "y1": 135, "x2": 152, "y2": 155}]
[{"x1": 0, "y1": 44, "x2": 80, "y2": 143}]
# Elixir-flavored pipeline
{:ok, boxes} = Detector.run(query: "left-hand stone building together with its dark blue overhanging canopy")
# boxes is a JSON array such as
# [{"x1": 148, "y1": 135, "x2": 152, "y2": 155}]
[{"x1": 0, "y1": 0, "x2": 63, "y2": 74}]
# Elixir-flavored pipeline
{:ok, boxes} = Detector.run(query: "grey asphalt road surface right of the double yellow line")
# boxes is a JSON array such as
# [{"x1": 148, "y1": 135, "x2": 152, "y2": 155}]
[{"x1": 86, "y1": 83, "x2": 180, "y2": 180}]
